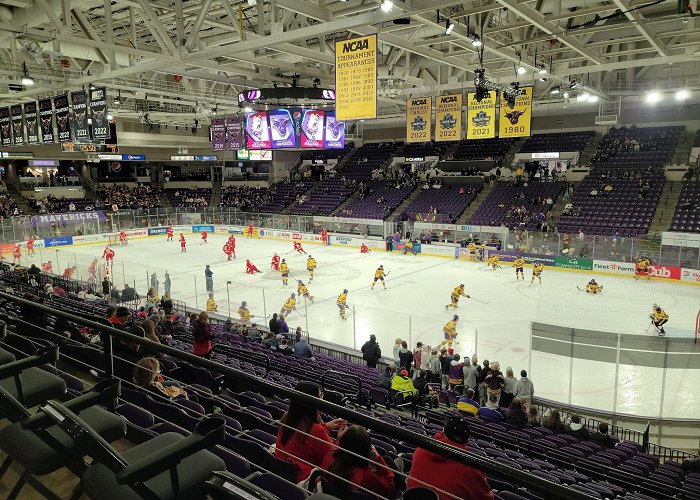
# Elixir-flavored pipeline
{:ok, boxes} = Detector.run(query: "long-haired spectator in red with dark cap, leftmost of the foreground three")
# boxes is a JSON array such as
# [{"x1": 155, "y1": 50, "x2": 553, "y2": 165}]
[{"x1": 275, "y1": 382, "x2": 347, "y2": 481}]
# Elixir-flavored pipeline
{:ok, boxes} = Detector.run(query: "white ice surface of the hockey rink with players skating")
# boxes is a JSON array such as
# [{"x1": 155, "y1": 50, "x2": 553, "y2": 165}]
[{"x1": 29, "y1": 234, "x2": 700, "y2": 417}]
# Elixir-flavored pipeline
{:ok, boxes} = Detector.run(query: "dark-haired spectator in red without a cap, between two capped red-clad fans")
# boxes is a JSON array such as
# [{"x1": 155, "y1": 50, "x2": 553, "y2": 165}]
[{"x1": 318, "y1": 425, "x2": 396, "y2": 498}]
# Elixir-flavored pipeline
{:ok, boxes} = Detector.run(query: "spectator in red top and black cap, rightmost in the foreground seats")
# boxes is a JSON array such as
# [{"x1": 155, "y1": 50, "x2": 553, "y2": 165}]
[{"x1": 407, "y1": 417, "x2": 494, "y2": 500}]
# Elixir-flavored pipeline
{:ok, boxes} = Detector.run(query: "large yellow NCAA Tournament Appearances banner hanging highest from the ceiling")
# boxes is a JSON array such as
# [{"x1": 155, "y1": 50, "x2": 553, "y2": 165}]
[{"x1": 335, "y1": 34, "x2": 377, "y2": 122}]
